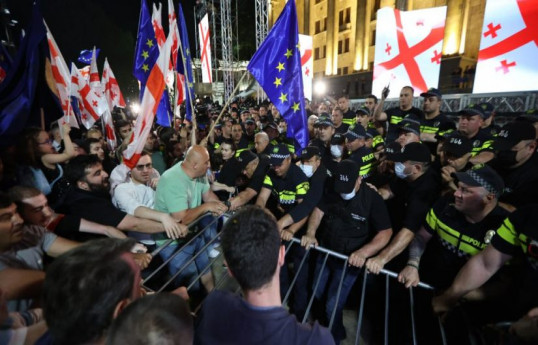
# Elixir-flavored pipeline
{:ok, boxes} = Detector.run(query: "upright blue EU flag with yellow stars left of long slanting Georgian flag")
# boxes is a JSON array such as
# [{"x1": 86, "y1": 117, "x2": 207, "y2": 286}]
[{"x1": 133, "y1": 0, "x2": 159, "y2": 83}]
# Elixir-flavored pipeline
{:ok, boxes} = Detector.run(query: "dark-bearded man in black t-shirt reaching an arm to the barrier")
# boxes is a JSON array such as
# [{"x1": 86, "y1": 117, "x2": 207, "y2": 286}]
[{"x1": 60, "y1": 155, "x2": 187, "y2": 238}]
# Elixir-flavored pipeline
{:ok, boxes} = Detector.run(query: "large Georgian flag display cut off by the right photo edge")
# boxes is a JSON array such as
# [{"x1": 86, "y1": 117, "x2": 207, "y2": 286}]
[{"x1": 473, "y1": 0, "x2": 538, "y2": 93}]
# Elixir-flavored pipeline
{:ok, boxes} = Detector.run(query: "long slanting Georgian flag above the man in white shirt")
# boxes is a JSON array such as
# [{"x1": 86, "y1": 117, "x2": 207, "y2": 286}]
[{"x1": 123, "y1": 30, "x2": 172, "y2": 169}]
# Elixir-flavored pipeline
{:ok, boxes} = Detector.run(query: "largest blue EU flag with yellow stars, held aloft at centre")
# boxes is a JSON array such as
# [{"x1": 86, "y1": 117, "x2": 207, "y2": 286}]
[{"x1": 247, "y1": 0, "x2": 308, "y2": 152}]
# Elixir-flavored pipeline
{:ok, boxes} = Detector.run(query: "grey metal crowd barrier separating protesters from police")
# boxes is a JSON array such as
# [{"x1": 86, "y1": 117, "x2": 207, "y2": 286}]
[{"x1": 139, "y1": 214, "x2": 447, "y2": 345}]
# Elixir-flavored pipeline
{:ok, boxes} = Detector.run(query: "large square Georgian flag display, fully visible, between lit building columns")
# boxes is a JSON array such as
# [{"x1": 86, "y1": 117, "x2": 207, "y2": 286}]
[{"x1": 372, "y1": 6, "x2": 446, "y2": 97}]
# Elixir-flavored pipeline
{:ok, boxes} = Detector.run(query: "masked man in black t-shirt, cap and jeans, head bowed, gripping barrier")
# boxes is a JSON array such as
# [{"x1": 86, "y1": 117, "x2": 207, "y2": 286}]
[{"x1": 301, "y1": 160, "x2": 392, "y2": 343}]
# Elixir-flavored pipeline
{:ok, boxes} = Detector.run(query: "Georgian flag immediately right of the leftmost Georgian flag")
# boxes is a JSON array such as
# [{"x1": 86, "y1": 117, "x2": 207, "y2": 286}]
[{"x1": 71, "y1": 63, "x2": 108, "y2": 129}]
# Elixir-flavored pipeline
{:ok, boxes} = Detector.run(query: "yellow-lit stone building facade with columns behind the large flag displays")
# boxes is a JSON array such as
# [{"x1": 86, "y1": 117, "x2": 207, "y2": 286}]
[{"x1": 269, "y1": 0, "x2": 486, "y2": 97}]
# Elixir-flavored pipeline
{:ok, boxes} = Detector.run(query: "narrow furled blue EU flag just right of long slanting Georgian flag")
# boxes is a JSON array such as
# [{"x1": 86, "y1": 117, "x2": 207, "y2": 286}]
[{"x1": 177, "y1": 3, "x2": 194, "y2": 121}]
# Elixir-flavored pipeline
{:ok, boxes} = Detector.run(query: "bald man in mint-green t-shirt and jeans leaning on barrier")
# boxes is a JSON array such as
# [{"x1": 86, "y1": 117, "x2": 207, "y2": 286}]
[{"x1": 155, "y1": 145, "x2": 228, "y2": 291}]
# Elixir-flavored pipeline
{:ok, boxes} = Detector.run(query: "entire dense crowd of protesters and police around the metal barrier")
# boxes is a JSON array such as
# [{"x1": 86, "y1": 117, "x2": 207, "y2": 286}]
[{"x1": 0, "y1": 87, "x2": 538, "y2": 344}]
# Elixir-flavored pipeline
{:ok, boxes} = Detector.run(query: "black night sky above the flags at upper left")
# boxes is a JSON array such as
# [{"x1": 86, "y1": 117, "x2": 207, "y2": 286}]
[{"x1": 3, "y1": 0, "x2": 255, "y2": 99}]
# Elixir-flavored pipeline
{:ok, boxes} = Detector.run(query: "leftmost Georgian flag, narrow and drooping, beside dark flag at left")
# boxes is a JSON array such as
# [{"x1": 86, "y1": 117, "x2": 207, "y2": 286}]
[{"x1": 45, "y1": 25, "x2": 78, "y2": 128}]
